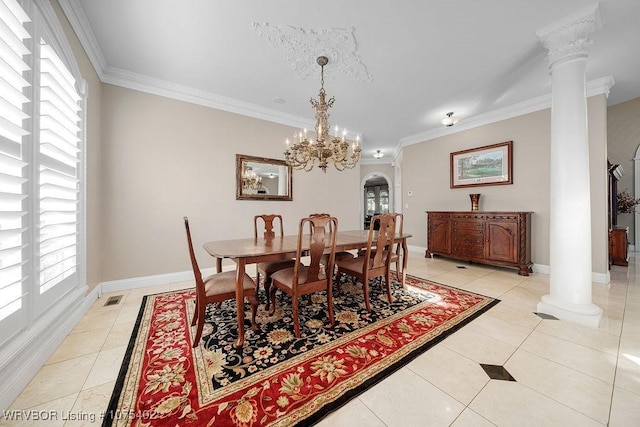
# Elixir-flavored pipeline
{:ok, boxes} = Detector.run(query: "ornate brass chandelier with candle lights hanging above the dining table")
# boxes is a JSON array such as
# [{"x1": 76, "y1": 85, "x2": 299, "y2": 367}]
[{"x1": 284, "y1": 56, "x2": 362, "y2": 173}]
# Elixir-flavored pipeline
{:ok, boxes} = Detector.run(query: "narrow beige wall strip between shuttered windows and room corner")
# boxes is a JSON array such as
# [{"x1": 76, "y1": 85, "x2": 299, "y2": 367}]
[{"x1": 51, "y1": 0, "x2": 104, "y2": 289}]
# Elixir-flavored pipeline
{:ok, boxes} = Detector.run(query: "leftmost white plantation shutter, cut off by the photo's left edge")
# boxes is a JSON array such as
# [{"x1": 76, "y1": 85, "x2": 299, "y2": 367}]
[{"x1": 0, "y1": 0, "x2": 31, "y2": 343}]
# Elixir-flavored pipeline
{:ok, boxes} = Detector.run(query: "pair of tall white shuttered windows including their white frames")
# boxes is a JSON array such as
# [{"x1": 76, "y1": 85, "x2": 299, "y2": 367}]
[{"x1": 0, "y1": 0, "x2": 85, "y2": 344}]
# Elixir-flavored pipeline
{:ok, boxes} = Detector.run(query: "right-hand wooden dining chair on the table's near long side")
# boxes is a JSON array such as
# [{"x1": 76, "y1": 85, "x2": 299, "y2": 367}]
[{"x1": 337, "y1": 214, "x2": 395, "y2": 311}]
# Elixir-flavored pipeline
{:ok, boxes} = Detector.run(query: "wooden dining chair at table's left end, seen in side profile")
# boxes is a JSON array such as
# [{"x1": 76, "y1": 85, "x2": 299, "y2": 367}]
[{"x1": 184, "y1": 216, "x2": 260, "y2": 347}]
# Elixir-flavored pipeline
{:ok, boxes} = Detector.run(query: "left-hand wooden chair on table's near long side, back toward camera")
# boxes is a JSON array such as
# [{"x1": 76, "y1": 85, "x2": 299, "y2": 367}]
[{"x1": 269, "y1": 216, "x2": 338, "y2": 338}]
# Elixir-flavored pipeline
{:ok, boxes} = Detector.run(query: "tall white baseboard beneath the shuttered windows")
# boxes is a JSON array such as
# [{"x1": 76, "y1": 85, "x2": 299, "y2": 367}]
[{"x1": 0, "y1": 287, "x2": 98, "y2": 410}]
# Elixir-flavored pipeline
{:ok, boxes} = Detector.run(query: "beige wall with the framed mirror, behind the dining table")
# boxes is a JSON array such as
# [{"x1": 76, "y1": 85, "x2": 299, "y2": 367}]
[{"x1": 102, "y1": 85, "x2": 360, "y2": 281}]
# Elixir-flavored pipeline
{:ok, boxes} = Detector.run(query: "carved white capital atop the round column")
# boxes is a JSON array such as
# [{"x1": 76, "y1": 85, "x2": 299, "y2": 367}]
[{"x1": 536, "y1": 3, "x2": 602, "y2": 67}]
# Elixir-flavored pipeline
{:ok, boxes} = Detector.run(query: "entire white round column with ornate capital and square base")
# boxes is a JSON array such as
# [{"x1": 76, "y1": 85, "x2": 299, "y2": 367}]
[{"x1": 537, "y1": 4, "x2": 604, "y2": 328}]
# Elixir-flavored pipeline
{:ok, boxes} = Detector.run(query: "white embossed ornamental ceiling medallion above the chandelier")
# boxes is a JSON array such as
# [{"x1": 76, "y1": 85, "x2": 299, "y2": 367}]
[{"x1": 253, "y1": 22, "x2": 372, "y2": 83}]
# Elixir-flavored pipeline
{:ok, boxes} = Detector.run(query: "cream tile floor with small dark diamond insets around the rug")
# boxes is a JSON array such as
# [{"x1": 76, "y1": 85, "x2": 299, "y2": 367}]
[{"x1": 0, "y1": 253, "x2": 640, "y2": 427}]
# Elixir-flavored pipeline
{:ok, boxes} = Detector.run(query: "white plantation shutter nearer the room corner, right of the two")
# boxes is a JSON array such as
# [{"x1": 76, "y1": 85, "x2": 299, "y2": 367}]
[{"x1": 38, "y1": 40, "x2": 81, "y2": 300}]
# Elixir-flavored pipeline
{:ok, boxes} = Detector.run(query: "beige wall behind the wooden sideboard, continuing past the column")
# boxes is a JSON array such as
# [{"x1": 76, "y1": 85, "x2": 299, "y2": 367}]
[{"x1": 401, "y1": 95, "x2": 607, "y2": 274}]
